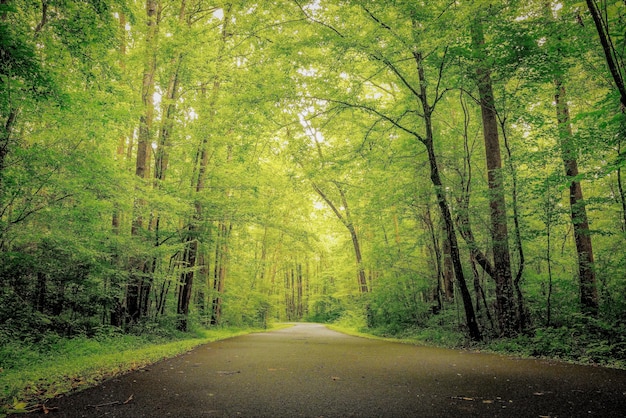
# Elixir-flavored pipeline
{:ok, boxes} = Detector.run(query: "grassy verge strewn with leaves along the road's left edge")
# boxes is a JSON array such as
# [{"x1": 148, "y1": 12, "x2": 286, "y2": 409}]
[{"x1": 0, "y1": 324, "x2": 288, "y2": 418}]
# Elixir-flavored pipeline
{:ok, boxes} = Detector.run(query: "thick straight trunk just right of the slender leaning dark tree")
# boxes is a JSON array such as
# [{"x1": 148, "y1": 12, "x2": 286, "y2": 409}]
[{"x1": 472, "y1": 16, "x2": 519, "y2": 336}]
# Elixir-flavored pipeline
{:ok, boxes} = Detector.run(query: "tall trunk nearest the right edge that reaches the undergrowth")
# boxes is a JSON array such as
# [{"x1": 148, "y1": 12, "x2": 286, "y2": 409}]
[{"x1": 554, "y1": 78, "x2": 598, "y2": 315}]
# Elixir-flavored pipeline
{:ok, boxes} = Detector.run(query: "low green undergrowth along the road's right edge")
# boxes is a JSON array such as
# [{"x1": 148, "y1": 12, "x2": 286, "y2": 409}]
[{"x1": 328, "y1": 305, "x2": 626, "y2": 369}]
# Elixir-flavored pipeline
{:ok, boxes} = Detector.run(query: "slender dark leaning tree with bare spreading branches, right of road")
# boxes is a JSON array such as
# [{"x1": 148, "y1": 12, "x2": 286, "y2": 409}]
[{"x1": 290, "y1": 2, "x2": 481, "y2": 340}]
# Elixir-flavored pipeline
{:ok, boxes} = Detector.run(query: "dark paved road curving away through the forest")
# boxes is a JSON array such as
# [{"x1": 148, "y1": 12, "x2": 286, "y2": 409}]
[{"x1": 20, "y1": 324, "x2": 626, "y2": 418}]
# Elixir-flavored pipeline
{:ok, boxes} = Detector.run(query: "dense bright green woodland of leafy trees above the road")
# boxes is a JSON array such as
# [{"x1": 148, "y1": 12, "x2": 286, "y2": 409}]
[{"x1": 0, "y1": 0, "x2": 626, "y2": 361}]
